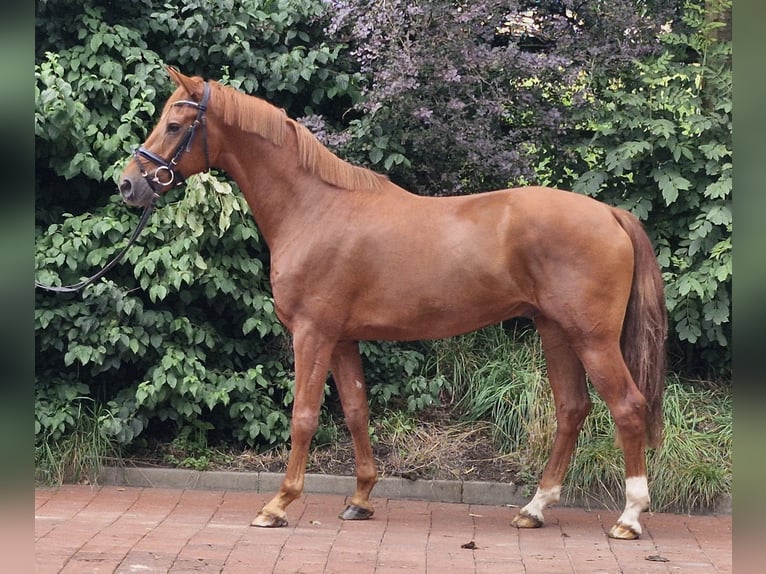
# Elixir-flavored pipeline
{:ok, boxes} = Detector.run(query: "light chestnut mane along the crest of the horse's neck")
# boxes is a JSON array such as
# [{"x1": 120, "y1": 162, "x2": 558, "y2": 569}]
[{"x1": 211, "y1": 82, "x2": 388, "y2": 194}]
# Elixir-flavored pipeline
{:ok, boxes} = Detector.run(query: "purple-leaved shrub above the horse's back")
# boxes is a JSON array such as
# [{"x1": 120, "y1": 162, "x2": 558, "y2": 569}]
[{"x1": 328, "y1": 0, "x2": 668, "y2": 195}]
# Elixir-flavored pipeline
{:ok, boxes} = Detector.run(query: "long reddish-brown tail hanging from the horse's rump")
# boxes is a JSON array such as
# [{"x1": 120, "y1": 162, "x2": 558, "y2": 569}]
[{"x1": 612, "y1": 208, "x2": 668, "y2": 447}]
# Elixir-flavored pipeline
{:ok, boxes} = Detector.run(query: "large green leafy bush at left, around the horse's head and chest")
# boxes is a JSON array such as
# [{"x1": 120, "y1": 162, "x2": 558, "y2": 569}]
[{"x1": 35, "y1": 0, "x2": 396, "y2": 460}]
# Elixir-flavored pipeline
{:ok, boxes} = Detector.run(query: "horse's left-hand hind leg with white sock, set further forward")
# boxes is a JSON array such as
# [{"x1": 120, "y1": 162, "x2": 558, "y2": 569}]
[{"x1": 511, "y1": 316, "x2": 591, "y2": 528}]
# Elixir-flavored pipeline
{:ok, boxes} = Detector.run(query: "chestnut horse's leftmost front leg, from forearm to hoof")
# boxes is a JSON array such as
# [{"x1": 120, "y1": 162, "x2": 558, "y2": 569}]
[{"x1": 251, "y1": 331, "x2": 335, "y2": 528}]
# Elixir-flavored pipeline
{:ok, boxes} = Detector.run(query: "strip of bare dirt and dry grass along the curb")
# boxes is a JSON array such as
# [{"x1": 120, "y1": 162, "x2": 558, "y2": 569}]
[{"x1": 126, "y1": 409, "x2": 528, "y2": 484}]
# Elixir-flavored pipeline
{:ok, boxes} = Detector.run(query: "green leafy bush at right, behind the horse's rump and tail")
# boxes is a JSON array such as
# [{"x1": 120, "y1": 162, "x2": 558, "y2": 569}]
[{"x1": 565, "y1": 0, "x2": 732, "y2": 378}]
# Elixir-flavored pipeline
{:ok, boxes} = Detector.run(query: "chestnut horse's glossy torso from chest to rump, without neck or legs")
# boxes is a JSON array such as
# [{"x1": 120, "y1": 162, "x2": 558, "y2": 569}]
[{"x1": 272, "y1": 188, "x2": 632, "y2": 339}]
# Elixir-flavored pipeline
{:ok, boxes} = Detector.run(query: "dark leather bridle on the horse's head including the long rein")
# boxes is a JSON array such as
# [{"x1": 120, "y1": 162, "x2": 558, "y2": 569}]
[{"x1": 35, "y1": 82, "x2": 210, "y2": 293}]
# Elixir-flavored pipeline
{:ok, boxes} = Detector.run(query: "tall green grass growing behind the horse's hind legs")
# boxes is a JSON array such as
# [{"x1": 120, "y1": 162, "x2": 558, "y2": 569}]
[{"x1": 428, "y1": 326, "x2": 732, "y2": 512}]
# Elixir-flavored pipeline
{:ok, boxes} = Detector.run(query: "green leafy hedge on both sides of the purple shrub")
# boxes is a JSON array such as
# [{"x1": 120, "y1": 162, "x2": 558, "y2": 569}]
[{"x1": 35, "y1": 0, "x2": 731, "y2": 460}]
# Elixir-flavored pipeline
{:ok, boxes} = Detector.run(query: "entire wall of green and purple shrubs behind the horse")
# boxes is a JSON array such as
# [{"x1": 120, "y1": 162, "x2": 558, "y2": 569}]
[{"x1": 35, "y1": 0, "x2": 731, "y2": 476}]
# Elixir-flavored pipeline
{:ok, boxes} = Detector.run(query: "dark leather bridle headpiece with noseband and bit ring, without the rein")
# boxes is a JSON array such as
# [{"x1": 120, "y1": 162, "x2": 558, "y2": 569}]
[{"x1": 133, "y1": 82, "x2": 210, "y2": 188}]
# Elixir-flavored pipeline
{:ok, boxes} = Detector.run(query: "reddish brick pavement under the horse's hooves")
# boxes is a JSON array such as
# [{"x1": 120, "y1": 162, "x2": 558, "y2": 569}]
[{"x1": 35, "y1": 486, "x2": 732, "y2": 574}]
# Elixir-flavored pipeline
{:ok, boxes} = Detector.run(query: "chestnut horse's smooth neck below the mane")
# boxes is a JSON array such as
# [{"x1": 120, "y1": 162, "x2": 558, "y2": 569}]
[{"x1": 216, "y1": 121, "x2": 331, "y2": 249}]
